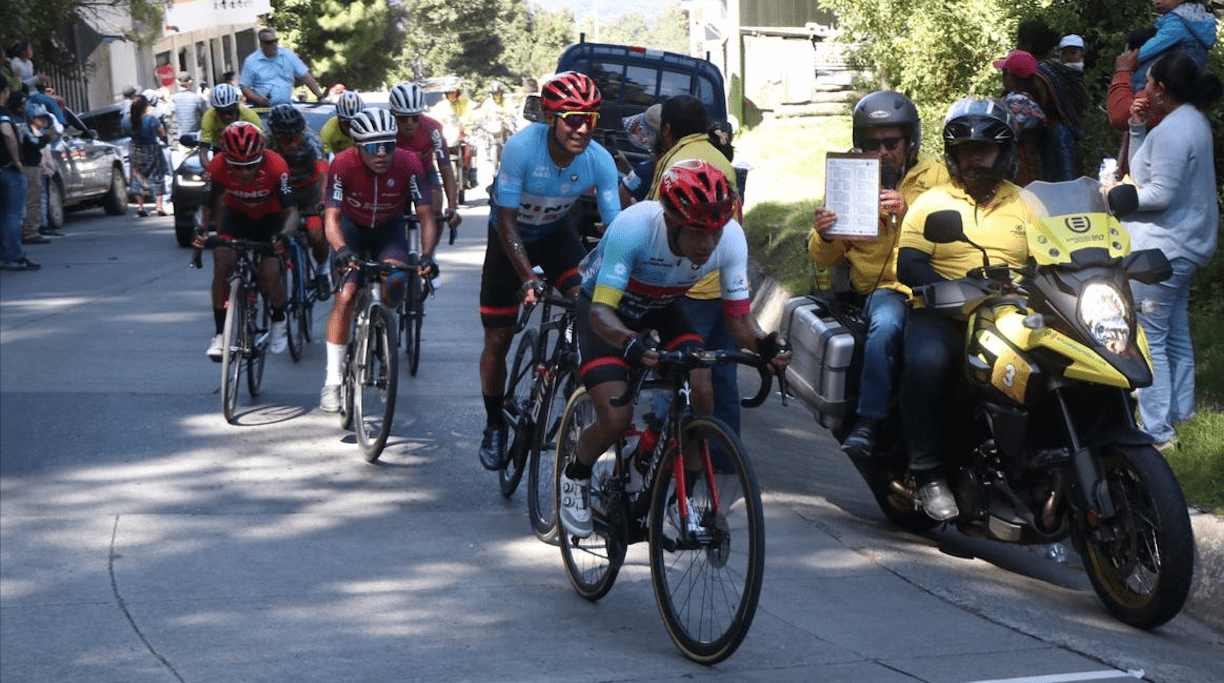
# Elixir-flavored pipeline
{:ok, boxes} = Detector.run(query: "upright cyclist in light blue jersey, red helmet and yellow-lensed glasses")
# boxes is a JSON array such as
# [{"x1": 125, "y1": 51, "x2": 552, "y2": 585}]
[{"x1": 480, "y1": 71, "x2": 621, "y2": 470}]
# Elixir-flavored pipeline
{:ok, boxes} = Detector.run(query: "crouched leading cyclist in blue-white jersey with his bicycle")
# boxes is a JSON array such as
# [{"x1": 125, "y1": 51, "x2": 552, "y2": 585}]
[{"x1": 557, "y1": 159, "x2": 791, "y2": 663}]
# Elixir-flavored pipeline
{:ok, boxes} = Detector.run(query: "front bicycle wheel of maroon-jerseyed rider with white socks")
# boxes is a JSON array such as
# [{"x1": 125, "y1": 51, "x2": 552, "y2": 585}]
[{"x1": 353, "y1": 306, "x2": 399, "y2": 463}]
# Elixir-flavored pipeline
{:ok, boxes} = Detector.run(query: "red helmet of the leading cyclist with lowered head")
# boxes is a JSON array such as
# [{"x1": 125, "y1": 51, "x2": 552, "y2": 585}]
[{"x1": 659, "y1": 159, "x2": 739, "y2": 230}]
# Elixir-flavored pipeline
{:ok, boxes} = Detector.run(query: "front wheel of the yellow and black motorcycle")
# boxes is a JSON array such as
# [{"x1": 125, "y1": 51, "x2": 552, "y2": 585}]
[{"x1": 1083, "y1": 446, "x2": 1195, "y2": 628}]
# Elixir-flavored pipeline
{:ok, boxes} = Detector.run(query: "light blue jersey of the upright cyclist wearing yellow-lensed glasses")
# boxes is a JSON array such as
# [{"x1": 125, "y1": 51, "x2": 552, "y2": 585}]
[{"x1": 488, "y1": 124, "x2": 621, "y2": 242}]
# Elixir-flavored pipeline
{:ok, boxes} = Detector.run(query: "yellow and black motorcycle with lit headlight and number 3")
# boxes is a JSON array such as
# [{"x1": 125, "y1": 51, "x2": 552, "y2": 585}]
[{"x1": 854, "y1": 177, "x2": 1195, "y2": 628}]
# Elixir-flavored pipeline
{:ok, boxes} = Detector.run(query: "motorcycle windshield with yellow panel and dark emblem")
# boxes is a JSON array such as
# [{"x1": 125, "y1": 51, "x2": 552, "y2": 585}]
[{"x1": 1021, "y1": 176, "x2": 1131, "y2": 266}]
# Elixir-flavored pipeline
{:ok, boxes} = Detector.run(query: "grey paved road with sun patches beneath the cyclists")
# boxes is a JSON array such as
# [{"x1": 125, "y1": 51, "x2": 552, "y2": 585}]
[{"x1": 0, "y1": 194, "x2": 1224, "y2": 683}]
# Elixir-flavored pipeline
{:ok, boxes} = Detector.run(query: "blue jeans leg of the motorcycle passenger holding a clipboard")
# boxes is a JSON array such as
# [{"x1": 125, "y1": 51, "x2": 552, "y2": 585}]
[{"x1": 858, "y1": 289, "x2": 909, "y2": 420}]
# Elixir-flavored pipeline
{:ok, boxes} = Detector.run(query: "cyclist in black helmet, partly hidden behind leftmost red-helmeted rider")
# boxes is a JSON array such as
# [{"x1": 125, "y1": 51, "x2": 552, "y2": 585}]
[{"x1": 267, "y1": 104, "x2": 332, "y2": 301}]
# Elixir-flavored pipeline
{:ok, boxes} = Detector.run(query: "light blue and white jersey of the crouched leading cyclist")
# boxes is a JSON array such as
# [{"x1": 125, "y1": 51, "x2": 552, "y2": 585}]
[{"x1": 579, "y1": 201, "x2": 750, "y2": 327}]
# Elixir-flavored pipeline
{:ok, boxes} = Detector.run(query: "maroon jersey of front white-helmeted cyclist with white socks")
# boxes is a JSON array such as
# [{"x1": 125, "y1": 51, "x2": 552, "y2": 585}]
[{"x1": 326, "y1": 147, "x2": 431, "y2": 228}]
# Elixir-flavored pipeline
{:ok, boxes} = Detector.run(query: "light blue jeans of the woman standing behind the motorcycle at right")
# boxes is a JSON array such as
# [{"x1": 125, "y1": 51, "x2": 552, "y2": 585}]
[{"x1": 1131, "y1": 258, "x2": 1198, "y2": 443}]
